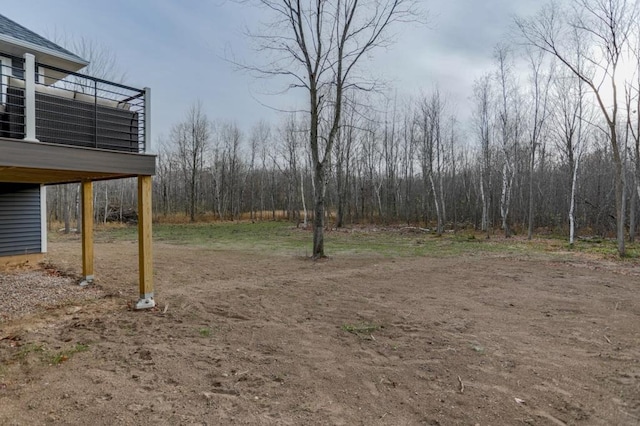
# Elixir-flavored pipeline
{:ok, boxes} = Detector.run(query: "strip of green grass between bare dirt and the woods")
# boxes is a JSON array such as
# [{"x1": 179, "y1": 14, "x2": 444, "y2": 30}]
[{"x1": 80, "y1": 221, "x2": 640, "y2": 259}]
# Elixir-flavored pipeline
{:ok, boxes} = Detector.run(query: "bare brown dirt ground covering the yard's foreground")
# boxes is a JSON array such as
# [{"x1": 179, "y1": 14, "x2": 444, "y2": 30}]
[{"x1": 0, "y1": 241, "x2": 640, "y2": 425}]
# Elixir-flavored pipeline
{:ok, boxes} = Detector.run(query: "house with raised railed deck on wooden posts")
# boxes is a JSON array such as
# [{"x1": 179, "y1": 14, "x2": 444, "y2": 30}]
[{"x1": 0, "y1": 15, "x2": 156, "y2": 309}]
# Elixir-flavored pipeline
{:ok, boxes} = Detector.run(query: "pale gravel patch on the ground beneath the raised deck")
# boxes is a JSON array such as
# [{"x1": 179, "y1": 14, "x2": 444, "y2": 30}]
[{"x1": 0, "y1": 268, "x2": 100, "y2": 323}]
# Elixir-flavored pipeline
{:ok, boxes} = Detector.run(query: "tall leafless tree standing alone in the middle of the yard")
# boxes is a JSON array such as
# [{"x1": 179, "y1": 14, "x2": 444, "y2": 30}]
[{"x1": 248, "y1": 0, "x2": 414, "y2": 259}]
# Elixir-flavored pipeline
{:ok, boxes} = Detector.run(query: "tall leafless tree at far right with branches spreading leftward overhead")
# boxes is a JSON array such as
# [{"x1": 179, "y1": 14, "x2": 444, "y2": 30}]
[{"x1": 516, "y1": 0, "x2": 638, "y2": 256}]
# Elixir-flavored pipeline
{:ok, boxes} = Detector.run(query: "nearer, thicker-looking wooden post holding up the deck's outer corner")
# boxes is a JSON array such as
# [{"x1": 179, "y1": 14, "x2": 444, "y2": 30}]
[{"x1": 136, "y1": 176, "x2": 156, "y2": 309}]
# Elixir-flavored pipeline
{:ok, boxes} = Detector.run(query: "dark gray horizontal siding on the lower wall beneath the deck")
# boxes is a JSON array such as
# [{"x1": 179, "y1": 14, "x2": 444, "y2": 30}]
[{"x1": 0, "y1": 183, "x2": 42, "y2": 256}]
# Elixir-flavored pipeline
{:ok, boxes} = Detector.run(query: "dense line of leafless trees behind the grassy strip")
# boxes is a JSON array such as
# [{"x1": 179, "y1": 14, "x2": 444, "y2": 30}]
[{"x1": 49, "y1": 85, "x2": 637, "y2": 240}]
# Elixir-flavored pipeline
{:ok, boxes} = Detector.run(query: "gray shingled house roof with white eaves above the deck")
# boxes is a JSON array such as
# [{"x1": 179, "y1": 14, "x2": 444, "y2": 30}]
[{"x1": 0, "y1": 14, "x2": 89, "y2": 71}]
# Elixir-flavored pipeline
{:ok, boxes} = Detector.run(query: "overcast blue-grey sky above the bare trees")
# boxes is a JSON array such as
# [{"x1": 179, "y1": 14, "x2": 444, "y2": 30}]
[{"x1": 1, "y1": 0, "x2": 540, "y2": 150}]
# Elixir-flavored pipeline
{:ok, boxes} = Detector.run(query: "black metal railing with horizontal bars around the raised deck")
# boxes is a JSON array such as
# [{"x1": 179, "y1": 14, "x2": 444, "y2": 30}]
[{"x1": 0, "y1": 54, "x2": 149, "y2": 152}]
